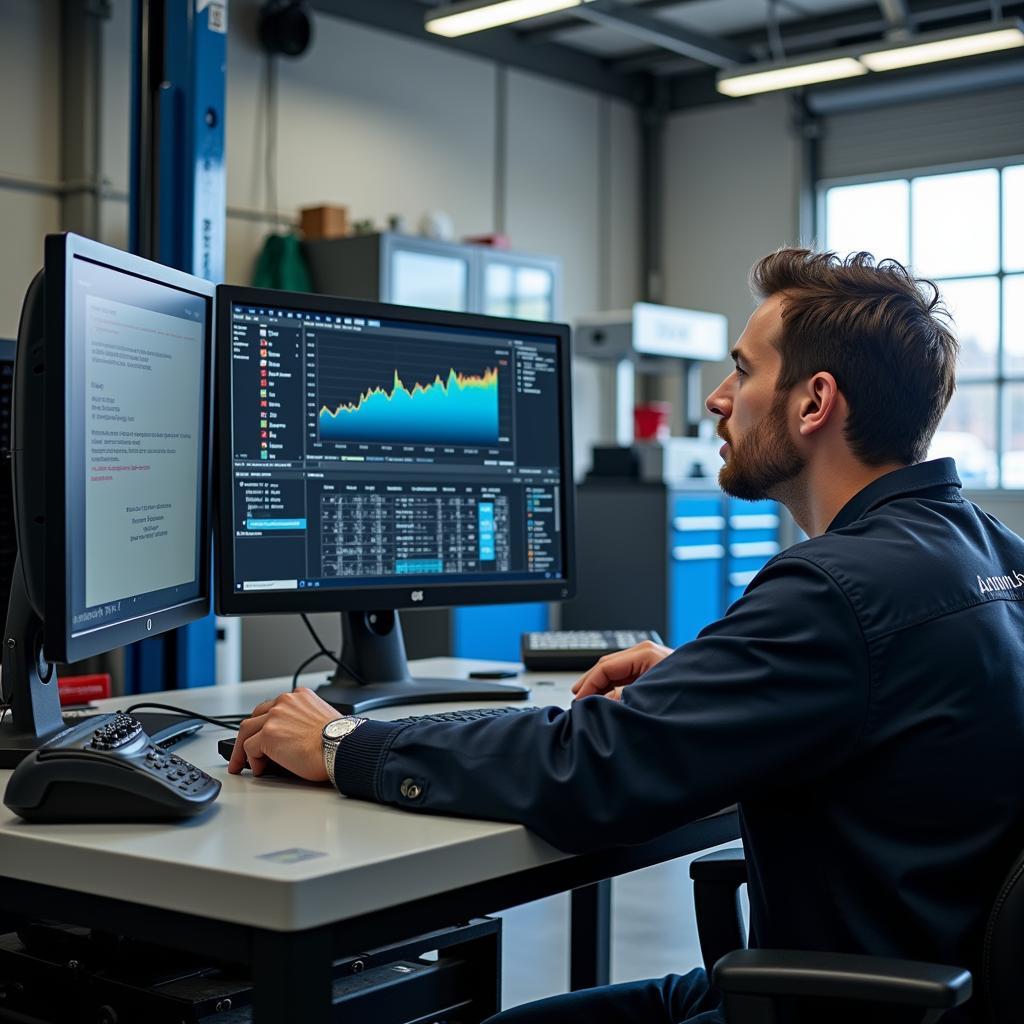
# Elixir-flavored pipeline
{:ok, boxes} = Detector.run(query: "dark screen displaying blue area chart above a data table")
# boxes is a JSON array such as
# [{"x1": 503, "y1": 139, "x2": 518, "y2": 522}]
[{"x1": 231, "y1": 305, "x2": 563, "y2": 591}]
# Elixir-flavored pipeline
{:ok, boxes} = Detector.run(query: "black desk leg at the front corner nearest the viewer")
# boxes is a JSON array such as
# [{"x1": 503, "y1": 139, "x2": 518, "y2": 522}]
[{"x1": 252, "y1": 928, "x2": 334, "y2": 1024}]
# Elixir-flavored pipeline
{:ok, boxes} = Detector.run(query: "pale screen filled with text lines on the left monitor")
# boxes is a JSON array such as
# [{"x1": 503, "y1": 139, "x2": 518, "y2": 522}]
[{"x1": 65, "y1": 256, "x2": 207, "y2": 637}]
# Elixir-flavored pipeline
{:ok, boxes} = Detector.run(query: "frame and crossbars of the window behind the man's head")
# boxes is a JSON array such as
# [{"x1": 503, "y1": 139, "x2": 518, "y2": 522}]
[{"x1": 814, "y1": 153, "x2": 1024, "y2": 499}]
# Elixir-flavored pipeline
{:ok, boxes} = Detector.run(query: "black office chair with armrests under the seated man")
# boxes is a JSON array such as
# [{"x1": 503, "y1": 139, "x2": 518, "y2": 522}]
[{"x1": 690, "y1": 850, "x2": 1024, "y2": 1024}]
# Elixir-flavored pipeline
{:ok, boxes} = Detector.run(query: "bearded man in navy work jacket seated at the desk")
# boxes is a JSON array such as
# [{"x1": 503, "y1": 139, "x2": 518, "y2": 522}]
[{"x1": 229, "y1": 249, "x2": 1024, "y2": 1022}]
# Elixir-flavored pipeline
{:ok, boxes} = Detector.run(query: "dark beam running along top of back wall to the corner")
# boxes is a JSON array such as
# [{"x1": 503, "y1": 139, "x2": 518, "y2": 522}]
[{"x1": 310, "y1": 0, "x2": 650, "y2": 105}]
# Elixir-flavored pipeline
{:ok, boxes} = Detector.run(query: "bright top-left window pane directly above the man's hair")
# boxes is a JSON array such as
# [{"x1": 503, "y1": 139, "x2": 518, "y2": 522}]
[{"x1": 825, "y1": 181, "x2": 910, "y2": 263}]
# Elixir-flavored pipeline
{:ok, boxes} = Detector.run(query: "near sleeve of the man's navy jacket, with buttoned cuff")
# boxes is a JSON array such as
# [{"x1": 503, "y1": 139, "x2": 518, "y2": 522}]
[{"x1": 335, "y1": 553, "x2": 870, "y2": 853}]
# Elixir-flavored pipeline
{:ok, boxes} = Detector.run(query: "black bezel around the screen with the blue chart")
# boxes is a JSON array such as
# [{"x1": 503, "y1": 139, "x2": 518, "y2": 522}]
[{"x1": 214, "y1": 285, "x2": 575, "y2": 615}]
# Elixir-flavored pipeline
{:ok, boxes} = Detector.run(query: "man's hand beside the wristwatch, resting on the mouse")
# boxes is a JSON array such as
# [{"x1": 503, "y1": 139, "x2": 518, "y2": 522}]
[{"x1": 227, "y1": 687, "x2": 341, "y2": 782}]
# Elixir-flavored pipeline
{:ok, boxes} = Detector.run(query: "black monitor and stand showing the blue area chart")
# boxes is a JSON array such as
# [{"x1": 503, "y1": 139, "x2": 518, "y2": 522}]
[{"x1": 216, "y1": 286, "x2": 574, "y2": 713}]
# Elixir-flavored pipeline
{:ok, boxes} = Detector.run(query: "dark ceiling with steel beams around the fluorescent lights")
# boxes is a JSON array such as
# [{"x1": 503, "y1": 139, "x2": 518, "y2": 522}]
[{"x1": 311, "y1": 0, "x2": 1024, "y2": 109}]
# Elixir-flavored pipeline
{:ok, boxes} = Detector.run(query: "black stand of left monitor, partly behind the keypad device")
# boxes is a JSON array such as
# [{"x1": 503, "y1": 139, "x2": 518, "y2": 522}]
[{"x1": 0, "y1": 559, "x2": 203, "y2": 768}]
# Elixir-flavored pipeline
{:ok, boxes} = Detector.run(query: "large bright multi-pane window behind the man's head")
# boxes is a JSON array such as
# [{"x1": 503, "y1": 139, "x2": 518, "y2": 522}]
[{"x1": 819, "y1": 161, "x2": 1024, "y2": 488}]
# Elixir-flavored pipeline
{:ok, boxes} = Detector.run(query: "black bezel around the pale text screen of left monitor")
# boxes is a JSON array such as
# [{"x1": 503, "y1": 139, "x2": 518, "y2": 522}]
[{"x1": 43, "y1": 232, "x2": 216, "y2": 664}]
